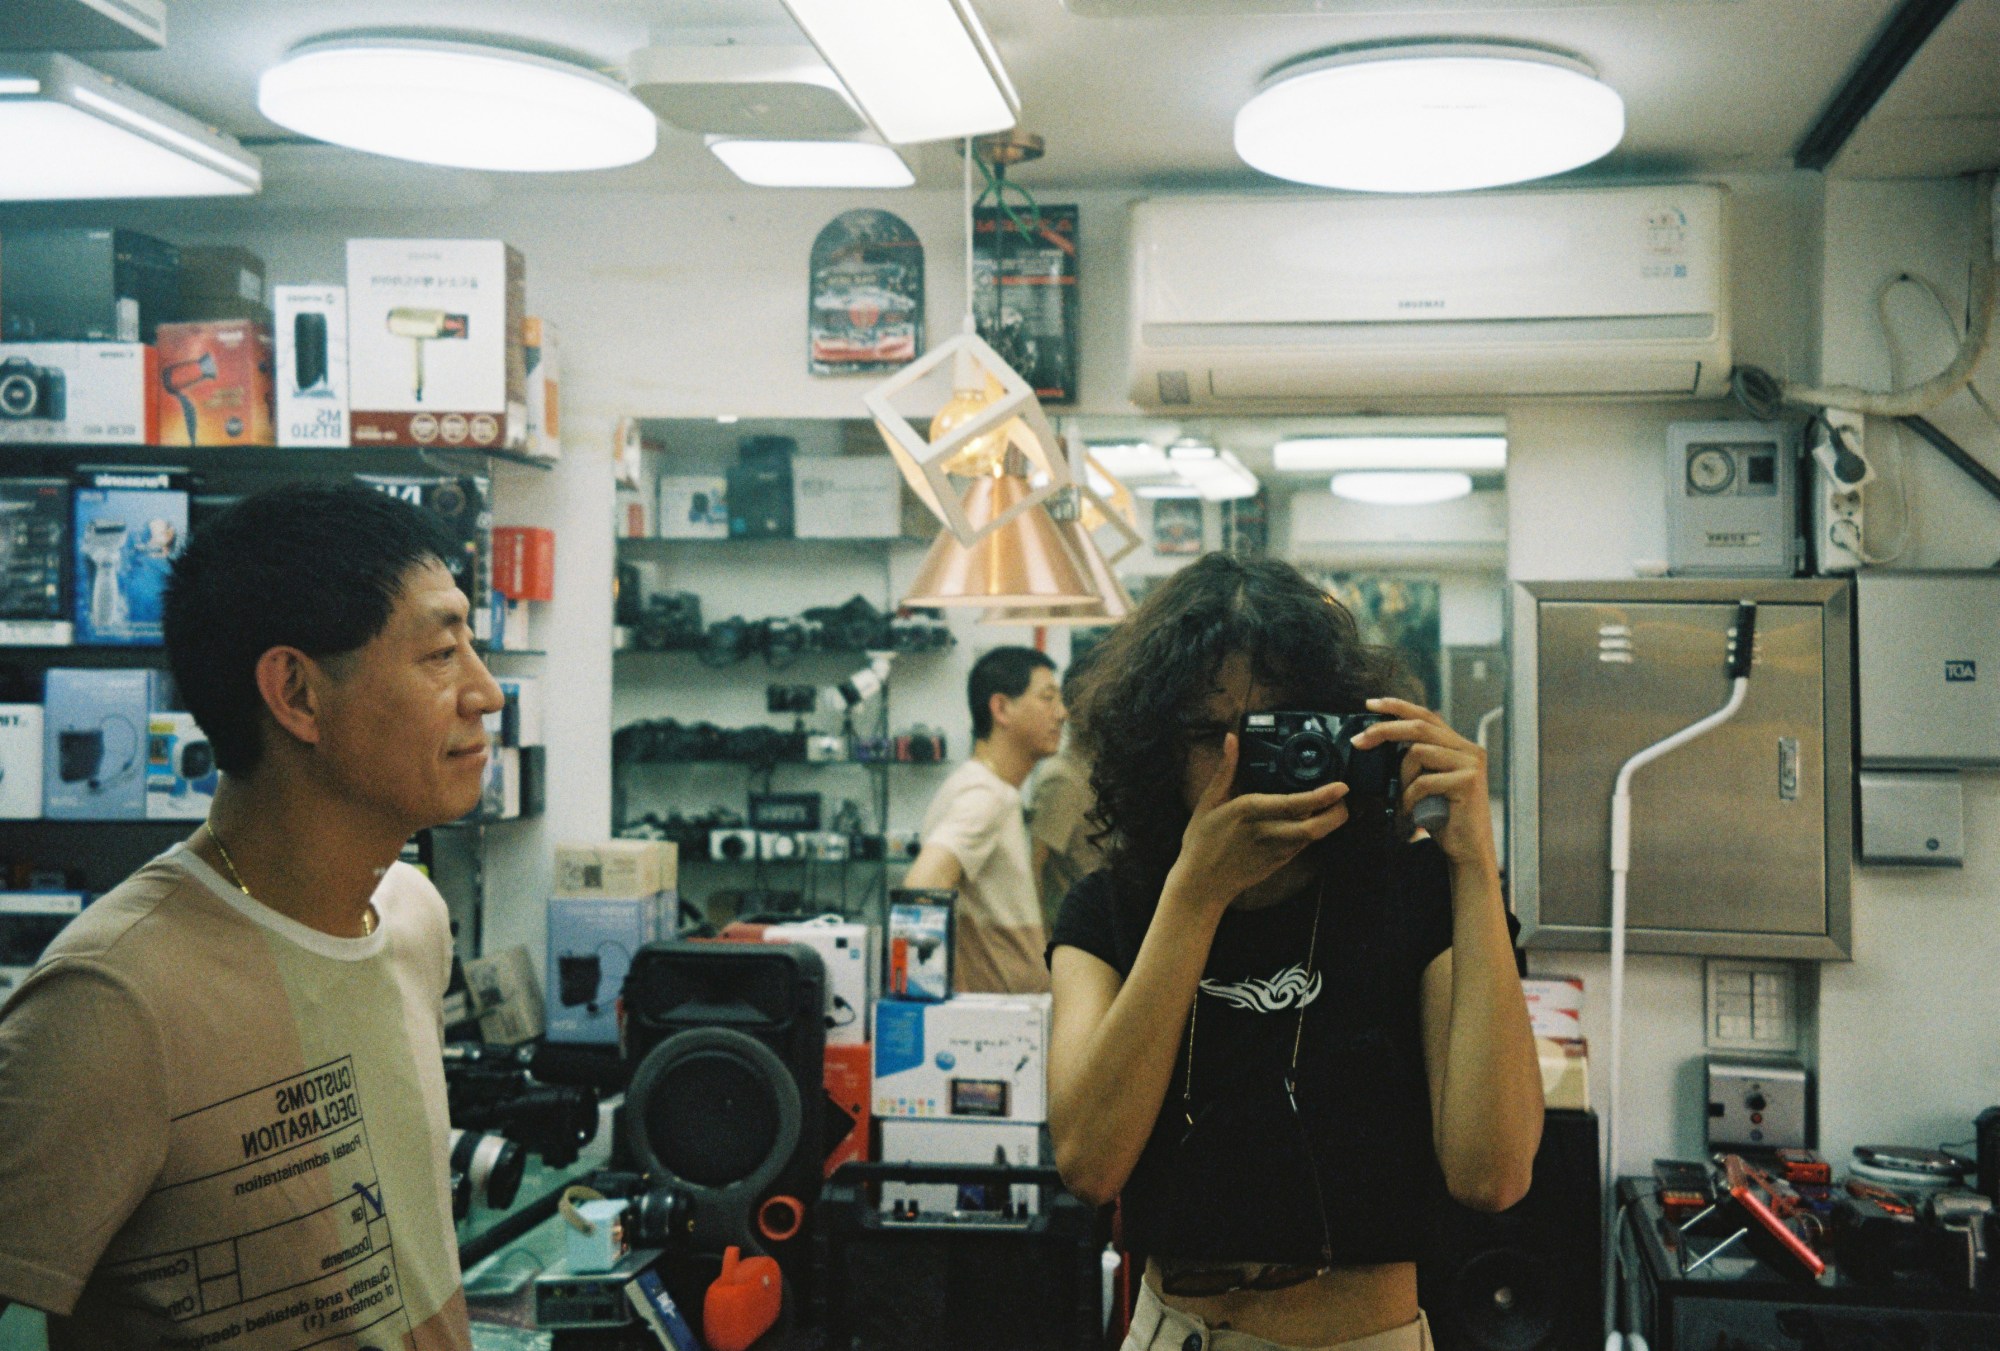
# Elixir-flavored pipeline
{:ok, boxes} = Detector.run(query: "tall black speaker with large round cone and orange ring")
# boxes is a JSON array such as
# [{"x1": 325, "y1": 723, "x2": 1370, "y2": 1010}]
[{"x1": 618, "y1": 943, "x2": 826, "y2": 1283}]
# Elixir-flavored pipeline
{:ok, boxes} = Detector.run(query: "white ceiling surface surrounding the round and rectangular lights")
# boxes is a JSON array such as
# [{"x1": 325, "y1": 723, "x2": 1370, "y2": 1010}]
[{"x1": 50, "y1": 0, "x2": 2000, "y2": 200}]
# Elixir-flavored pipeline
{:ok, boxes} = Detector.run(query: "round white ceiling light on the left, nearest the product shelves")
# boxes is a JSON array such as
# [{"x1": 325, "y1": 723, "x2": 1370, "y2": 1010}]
[{"x1": 256, "y1": 38, "x2": 660, "y2": 174}]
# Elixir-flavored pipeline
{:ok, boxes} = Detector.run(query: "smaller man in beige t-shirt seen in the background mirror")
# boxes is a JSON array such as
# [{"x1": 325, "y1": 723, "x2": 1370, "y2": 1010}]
[{"x1": 902, "y1": 648, "x2": 1068, "y2": 993}]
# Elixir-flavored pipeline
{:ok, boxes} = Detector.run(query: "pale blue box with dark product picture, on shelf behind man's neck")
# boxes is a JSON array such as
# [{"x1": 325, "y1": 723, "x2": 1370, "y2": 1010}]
[{"x1": 42, "y1": 666, "x2": 166, "y2": 821}]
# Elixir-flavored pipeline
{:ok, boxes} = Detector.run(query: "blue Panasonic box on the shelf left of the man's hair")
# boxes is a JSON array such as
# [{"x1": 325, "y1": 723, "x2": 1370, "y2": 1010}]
[{"x1": 70, "y1": 468, "x2": 188, "y2": 648}]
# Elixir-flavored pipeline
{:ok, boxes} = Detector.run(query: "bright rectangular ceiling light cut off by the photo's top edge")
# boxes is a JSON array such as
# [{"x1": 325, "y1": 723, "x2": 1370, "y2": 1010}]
[{"x1": 784, "y1": 0, "x2": 1020, "y2": 146}]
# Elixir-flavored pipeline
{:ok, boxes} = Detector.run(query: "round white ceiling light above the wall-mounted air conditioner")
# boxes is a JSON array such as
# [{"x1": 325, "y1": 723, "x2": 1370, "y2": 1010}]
[{"x1": 1236, "y1": 42, "x2": 1624, "y2": 192}]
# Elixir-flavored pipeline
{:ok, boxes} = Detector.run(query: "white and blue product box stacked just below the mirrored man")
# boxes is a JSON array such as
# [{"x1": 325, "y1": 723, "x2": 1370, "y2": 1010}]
[{"x1": 874, "y1": 995, "x2": 1048, "y2": 1121}]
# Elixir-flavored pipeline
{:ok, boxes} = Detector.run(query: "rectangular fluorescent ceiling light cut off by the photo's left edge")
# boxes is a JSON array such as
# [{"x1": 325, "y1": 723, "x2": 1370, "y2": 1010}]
[{"x1": 0, "y1": 54, "x2": 264, "y2": 202}]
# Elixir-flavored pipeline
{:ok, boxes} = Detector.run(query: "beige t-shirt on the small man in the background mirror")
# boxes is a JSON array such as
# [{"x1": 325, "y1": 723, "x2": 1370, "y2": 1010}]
[{"x1": 924, "y1": 759, "x2": 1048, "y2": 995}]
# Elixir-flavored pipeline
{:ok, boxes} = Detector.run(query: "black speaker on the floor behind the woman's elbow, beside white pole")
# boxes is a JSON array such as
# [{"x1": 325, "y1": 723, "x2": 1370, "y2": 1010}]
[{"x1": 1416, "y1": 1111, "x2": 1604, "y2": 1351}]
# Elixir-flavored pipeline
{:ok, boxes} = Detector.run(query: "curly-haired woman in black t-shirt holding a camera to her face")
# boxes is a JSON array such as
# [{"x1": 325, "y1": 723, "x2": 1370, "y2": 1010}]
[{"x1": 1050, "y1": 554, "x2": 1542, "y2": 1351}]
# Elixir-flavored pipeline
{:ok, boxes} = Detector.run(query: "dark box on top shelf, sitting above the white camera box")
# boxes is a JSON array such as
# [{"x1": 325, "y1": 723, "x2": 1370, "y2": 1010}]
[{"x1": 0, "y1": 228, "x2": 182, "y2": 342}]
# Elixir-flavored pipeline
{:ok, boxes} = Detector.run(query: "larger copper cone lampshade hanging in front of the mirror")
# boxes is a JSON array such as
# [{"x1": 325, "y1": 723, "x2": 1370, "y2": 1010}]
[{"x1": 902, "y1": 474, "x2": 1098, "y2": 606}]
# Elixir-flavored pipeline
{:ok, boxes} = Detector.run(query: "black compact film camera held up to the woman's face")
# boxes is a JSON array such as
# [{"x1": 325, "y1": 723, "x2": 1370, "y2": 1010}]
[{"x1": 1236, "y1": 709, "x2": 1452, "y2": 831}]
